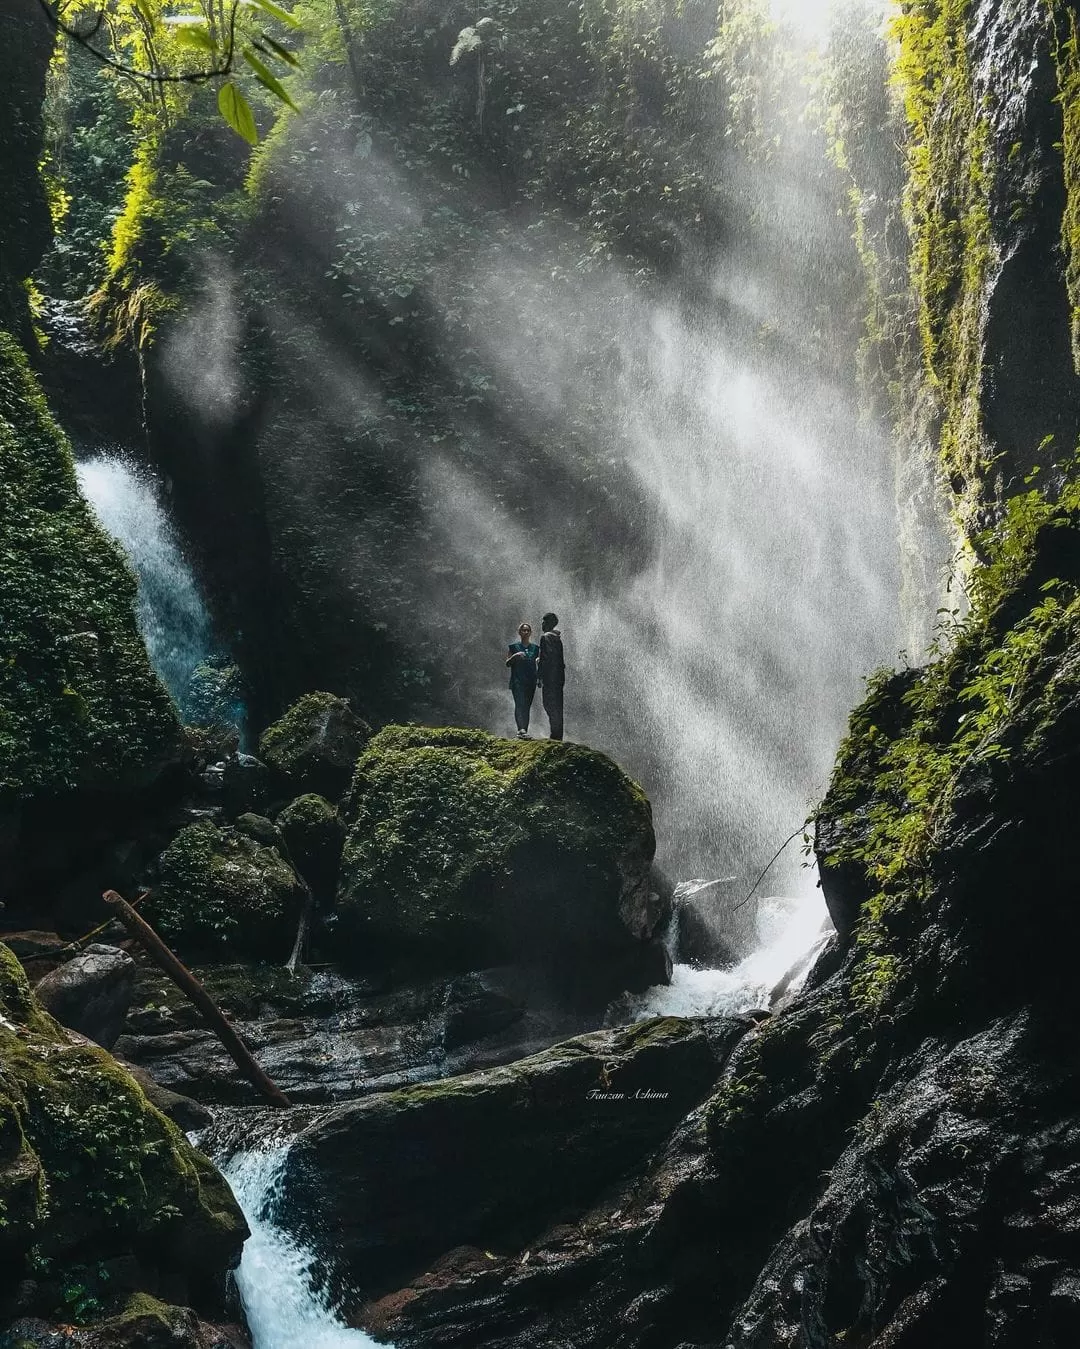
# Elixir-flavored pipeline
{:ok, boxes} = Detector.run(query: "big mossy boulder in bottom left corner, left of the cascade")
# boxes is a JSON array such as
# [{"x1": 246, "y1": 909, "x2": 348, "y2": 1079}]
[{"x1": 0, "y1": 944, "x2": 247, "y2": 1321}]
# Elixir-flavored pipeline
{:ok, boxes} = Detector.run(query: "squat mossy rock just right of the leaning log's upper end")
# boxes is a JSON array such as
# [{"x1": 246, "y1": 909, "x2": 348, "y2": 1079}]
[{"x1": 148, "y1": 820, "x2": 305, "y2": 959}]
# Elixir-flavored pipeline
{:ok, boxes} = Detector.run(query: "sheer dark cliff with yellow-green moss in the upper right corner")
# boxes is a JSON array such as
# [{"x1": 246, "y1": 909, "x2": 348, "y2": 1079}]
[{"x1": 879, "y1": 0, "x2": 1080, "y2": 532}]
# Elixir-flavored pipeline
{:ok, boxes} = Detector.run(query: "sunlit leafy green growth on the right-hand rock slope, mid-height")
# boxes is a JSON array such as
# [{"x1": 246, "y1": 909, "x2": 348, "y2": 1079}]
[{"x1": 818, "y1": 480, "x2": 1080, "y2": 1013}]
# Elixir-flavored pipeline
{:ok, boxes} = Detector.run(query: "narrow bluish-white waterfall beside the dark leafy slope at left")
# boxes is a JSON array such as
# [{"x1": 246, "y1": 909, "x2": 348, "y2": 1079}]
[{"x1": 76, "y1": 453, "x2": 214, "y2": 716}]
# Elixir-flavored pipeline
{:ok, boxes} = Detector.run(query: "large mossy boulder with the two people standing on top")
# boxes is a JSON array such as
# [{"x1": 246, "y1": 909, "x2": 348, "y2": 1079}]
[{"x1": 338, "y1": 726, "x2": 665, "y2": 992}]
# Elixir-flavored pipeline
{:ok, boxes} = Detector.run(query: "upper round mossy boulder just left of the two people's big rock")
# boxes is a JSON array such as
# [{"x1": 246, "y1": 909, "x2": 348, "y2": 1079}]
[{"x1": 259, "y1": 693, "x2": 371, "y2": 801}]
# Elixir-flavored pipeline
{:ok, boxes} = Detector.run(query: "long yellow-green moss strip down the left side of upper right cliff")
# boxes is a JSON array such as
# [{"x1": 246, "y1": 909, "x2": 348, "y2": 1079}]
[{"x1": 891, "y1": 0, "x2": 994, "y2": 522}]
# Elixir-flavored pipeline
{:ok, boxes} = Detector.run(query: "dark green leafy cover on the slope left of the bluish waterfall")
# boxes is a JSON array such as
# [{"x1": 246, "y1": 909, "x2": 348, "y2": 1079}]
[{"x1": 0, "y1": 332, "x2": 178, "y2": 809}]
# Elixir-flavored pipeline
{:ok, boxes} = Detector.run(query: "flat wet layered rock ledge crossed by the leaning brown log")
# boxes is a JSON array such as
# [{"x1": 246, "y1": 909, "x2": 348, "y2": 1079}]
[{"x1": 115, "y1": 966, "x2": 600, "y2": 1105}]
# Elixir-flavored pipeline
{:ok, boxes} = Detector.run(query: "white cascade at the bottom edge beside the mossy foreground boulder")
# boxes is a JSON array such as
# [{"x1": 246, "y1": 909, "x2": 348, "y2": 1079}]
[{"x1": 222, "y1": 1144, "x2": 376, "y2": 1349}]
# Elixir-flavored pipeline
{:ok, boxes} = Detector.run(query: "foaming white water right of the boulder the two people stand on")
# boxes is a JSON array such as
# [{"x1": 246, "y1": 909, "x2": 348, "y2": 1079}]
[{"x1": 634, "y1": 890, "x2": 832, "y2": 1020}]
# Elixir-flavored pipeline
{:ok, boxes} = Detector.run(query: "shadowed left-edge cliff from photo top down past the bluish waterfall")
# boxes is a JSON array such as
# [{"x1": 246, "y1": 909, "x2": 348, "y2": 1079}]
[{"x1": 0, "y1": 0, "x2": 178, "y2": 907}]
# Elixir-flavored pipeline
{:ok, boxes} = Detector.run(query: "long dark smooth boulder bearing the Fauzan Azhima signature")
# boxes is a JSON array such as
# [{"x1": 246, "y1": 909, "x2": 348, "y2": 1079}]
[{"x1": 283, "y1": 1017, "x2": 746, "y2": 1304}]
